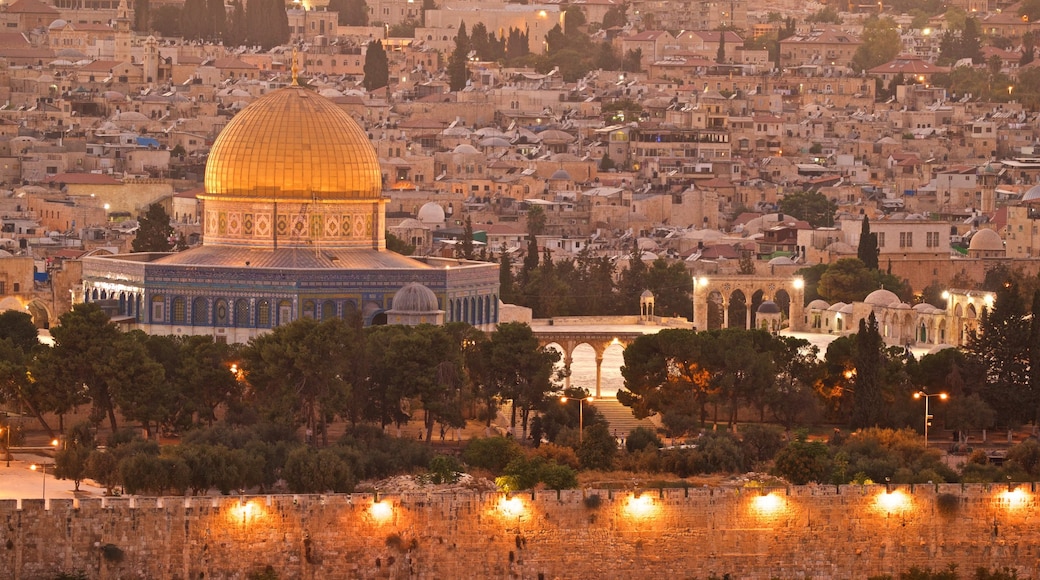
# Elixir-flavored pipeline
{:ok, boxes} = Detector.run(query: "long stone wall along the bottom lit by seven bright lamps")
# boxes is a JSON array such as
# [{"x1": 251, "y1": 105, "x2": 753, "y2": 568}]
[{"x1": 0, "y1": 484, "x2": 1040, "y2": 580}]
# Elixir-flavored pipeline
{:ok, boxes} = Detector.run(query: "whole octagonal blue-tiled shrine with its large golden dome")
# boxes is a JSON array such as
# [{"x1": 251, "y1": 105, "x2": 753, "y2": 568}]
[{"x1": 82, "y1": 79, "x2": 498, "y2": 342}]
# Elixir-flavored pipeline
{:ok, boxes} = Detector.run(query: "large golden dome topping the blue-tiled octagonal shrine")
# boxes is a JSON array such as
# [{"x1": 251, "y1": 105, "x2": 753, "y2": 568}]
[{"x1": 205, "y1": 85, "x2": 383, "y2": 202}]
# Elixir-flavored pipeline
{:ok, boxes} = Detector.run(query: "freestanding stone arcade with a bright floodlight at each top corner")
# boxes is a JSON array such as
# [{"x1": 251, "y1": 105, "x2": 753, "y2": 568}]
[{"x1": 694, "y1": 275, "x2": 807, "y2": 331}]
